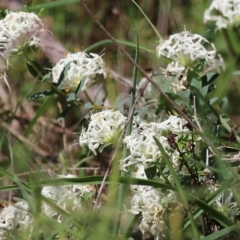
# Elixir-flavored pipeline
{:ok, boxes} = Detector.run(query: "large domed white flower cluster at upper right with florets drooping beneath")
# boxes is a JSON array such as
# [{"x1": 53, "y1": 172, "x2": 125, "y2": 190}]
[{"x1": 156, "y1": 31, "x2": 224, "y2": 92}]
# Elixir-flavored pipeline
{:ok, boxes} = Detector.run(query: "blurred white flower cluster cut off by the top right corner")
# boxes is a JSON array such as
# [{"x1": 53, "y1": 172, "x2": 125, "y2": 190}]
[{"x1": 204, "y1": 0, "x2": 240, "y2": 30}]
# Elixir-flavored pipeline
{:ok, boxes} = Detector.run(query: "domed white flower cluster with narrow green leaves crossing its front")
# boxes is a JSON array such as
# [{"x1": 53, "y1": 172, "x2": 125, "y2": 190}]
[{"x1": 52, "y1": 52, "x2": 106, "y2": 92}]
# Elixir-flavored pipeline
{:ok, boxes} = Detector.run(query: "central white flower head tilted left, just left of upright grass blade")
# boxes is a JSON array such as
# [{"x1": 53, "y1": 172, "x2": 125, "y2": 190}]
[{"x1": 79, "y1": 110, "x2": 127, "y2": 155}]
